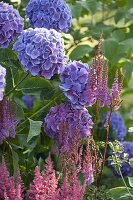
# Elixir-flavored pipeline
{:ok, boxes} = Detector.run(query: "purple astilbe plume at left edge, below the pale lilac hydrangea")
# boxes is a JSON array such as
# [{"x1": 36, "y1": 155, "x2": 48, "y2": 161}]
[{"x1": 0, "y1": 99, "x2": 17, "y2": 144}]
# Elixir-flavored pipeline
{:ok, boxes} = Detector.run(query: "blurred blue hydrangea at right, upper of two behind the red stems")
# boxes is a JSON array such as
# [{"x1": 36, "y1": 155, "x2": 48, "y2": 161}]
[{"x1": 102, "y1": 112, "x2": 127, "y2": 141}]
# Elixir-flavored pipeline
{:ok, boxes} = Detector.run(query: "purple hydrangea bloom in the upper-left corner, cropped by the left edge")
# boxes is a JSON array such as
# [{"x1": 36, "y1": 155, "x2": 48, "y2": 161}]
[{"x1": 0, "y1": 2, "x2": 24, "y2": 48}]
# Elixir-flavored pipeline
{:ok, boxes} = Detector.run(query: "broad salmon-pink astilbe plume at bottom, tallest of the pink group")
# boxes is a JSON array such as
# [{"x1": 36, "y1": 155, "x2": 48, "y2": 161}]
[{"x1": 27, "y1": 155, "x2": 58, "y2": 200}]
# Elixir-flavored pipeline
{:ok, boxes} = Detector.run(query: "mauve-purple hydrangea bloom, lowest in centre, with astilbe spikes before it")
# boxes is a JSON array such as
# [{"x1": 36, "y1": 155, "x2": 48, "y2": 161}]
[{"x1": 44, "y1": 102, "x2": 93, "y2": 151}]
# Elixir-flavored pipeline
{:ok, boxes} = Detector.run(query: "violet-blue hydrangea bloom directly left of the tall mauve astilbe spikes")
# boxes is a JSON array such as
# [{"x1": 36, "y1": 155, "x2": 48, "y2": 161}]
[{"x1": 60, "y1": 61, "x2": 96, "y2": 109}]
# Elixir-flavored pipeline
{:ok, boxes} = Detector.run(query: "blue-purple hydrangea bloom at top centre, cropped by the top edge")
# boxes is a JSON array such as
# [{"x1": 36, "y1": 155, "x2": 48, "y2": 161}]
[{"x1": 26, "y1": 0, "x2": 72, "y2": 32}]
